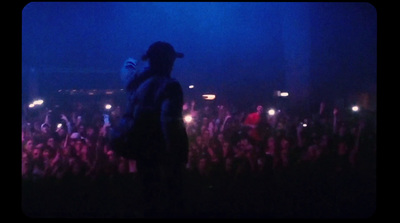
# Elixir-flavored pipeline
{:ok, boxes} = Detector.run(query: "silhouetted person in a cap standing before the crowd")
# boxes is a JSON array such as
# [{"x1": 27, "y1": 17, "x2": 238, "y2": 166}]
[{"x1": 121, "y1": 41, "x2": 188, "y2": 217}]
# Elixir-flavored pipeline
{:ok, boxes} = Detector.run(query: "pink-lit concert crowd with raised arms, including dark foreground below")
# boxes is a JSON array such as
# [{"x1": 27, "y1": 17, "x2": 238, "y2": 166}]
[{"x1": 21, "y1": 97, "x2": 376, "y2": 218}]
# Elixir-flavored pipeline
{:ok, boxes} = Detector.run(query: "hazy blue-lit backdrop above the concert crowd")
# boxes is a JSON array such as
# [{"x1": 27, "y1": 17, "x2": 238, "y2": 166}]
[{"x1": 22, "y1": 2, "x2": 377, "y2": 108}]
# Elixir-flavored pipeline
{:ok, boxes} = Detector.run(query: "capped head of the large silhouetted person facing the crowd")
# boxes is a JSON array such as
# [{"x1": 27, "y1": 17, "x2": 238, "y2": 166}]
[{"x1": 142, "y1": 41, "x2": 183, "y2": 75}]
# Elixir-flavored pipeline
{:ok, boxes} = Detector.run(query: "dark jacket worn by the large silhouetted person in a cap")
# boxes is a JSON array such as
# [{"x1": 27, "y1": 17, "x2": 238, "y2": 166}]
[{"x1": 121, "y1": 66, "x2": 188, "y2": 163}]
